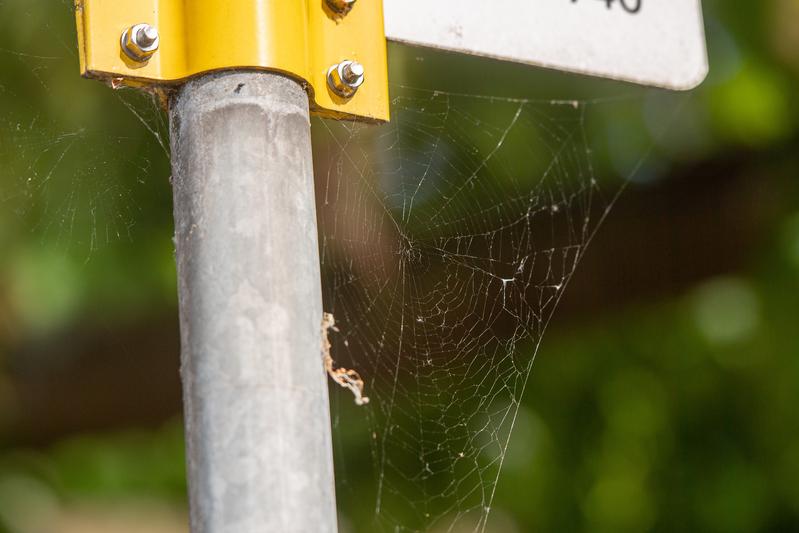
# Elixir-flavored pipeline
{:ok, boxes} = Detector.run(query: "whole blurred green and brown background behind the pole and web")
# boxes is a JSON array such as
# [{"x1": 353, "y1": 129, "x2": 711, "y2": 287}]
[{"x1": 0, "y1": 0, "x2": 799, "y2": 532}]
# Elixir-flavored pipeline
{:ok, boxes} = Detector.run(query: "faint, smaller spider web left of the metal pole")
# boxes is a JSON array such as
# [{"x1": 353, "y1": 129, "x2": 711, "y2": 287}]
[{"x1": 0, "y1": 0, "x2": 168, "y2": 261}]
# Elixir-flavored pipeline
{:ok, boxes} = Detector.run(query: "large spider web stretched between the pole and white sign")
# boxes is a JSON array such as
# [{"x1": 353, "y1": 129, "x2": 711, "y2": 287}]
[{"x1": 315, "y1": 86, "x2": 636, "y2": 531}]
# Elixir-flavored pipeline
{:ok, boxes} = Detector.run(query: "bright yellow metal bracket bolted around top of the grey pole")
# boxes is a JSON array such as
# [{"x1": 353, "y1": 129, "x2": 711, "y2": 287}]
[{"x1": 76, "y1": 0, "x2": 389, "y2": 121}]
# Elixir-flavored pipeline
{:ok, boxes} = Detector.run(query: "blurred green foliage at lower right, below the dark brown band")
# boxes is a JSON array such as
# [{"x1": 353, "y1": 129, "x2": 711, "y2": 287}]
[{"x1": 498, "y1": 252, "x2": 799, "y2": 532}]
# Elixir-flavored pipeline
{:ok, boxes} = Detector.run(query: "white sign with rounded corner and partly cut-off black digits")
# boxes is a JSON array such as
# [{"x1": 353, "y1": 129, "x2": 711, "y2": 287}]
[{"x1": 384, "y1": 0, "x2": 707, "y2": 90}]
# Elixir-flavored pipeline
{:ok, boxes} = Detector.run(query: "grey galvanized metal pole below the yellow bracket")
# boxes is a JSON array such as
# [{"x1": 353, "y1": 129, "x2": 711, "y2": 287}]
[{"x1": 169, "y1": 72, "x2": 336, "y2": 533}]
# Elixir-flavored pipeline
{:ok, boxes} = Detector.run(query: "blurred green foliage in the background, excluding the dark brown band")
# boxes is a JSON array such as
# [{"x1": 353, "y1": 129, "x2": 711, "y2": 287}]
[{"x1": 0, "y1": 0, "x2": 799, "y2": 532}]
